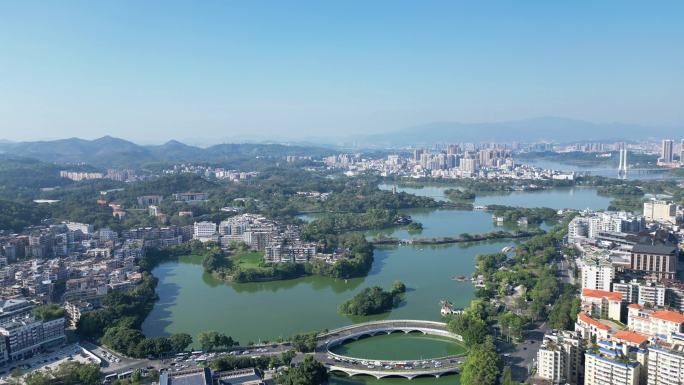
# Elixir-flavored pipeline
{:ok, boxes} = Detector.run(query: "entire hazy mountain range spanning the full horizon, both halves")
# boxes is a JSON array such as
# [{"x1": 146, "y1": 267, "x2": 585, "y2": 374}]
[{"x1": 0, "y1": 117, "x2": 684, "y2": 167}]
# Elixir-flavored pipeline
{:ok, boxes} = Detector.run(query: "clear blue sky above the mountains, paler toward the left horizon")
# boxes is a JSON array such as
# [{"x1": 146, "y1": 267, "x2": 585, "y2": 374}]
[{"x1": 0, "y1": 0, "x2": 684, "y2": 143}]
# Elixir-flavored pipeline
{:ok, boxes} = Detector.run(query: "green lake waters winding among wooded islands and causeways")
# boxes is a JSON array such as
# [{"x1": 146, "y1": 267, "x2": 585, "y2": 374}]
[{"x1": 143, "y1": 186, "x2": 608, "y2": 385}]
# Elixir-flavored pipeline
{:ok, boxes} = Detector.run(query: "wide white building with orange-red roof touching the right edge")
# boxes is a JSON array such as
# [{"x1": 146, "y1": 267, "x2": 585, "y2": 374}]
[{"x1": 627, "y1": 304, "x2": 684, "y2": 338}]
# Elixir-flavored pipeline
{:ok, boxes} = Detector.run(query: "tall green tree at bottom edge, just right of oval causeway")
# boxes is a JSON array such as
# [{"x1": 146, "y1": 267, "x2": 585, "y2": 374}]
[{"x1": 461, "y1": 336, "x2": 501, "y2": 385}]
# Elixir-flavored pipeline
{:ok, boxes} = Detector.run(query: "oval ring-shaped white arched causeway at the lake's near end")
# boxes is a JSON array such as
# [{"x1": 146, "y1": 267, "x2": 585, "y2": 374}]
[{"x1": 315, "y1": 320, "x2": 463, "y2": 379}]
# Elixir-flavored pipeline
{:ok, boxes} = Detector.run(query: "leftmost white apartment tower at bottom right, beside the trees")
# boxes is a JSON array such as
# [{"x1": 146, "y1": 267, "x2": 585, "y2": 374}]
[{"x1": 537, "y1": 330, "x2": 582, "y2": 385}]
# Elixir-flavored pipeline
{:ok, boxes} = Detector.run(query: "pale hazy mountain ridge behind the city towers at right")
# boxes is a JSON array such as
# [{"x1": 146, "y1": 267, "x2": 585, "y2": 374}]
[{"x1": 356, "y1": 117, "x2": 684, "y2": 146}]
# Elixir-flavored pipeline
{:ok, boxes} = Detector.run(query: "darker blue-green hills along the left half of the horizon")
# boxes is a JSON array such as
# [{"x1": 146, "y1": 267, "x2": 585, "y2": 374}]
[{"x1": 0, "y1": 136, "x2": 335, "y2": 167}]
